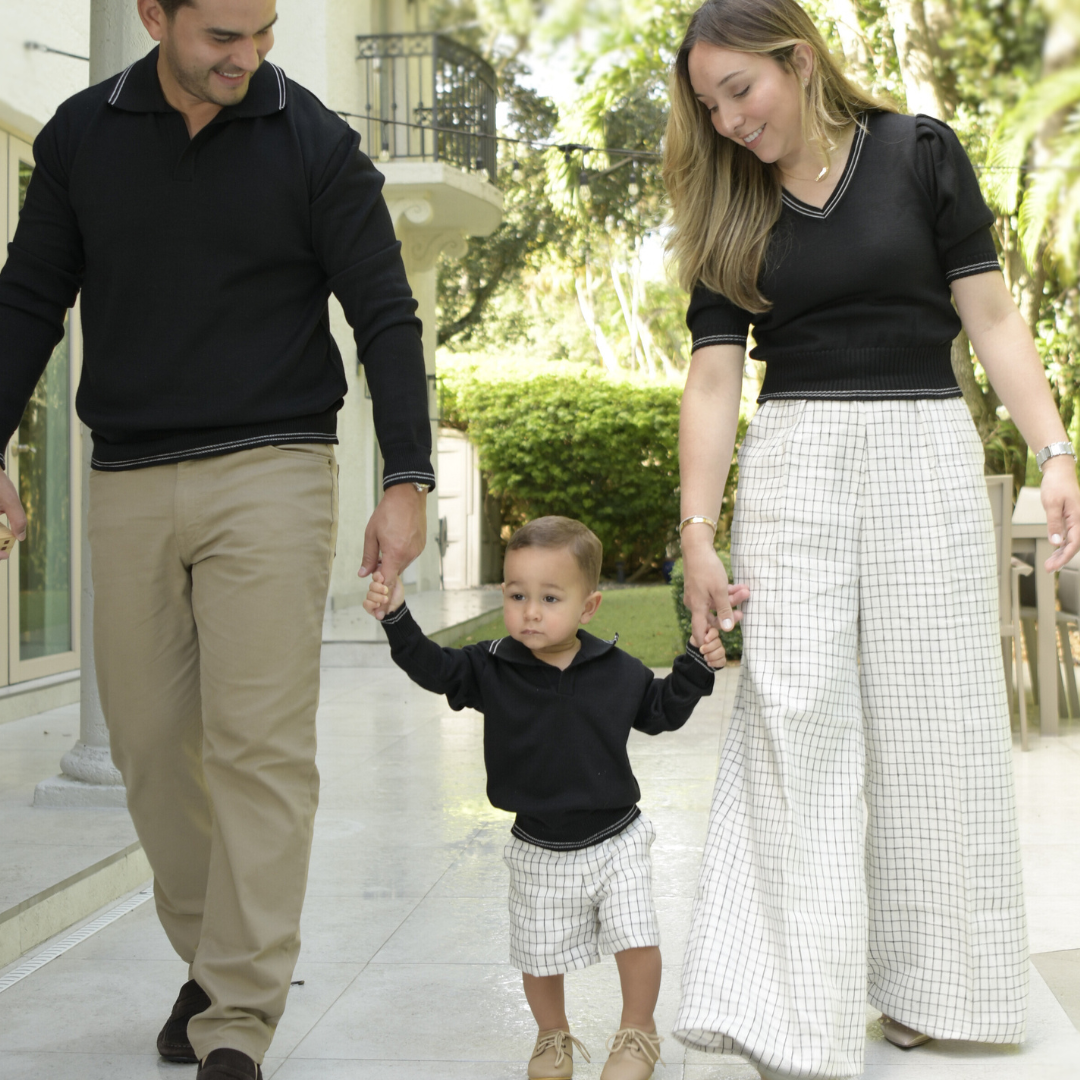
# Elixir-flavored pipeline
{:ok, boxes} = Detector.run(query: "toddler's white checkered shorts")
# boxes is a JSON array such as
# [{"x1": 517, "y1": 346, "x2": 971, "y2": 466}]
[{"x1": 502, "y1": 814, "x2": 660, "y2": 975}]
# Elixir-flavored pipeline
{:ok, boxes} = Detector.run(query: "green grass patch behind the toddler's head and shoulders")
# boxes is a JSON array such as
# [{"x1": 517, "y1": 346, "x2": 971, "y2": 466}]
[{"x1": 440, "y1": 585, "x2": 683, "y2": 667}]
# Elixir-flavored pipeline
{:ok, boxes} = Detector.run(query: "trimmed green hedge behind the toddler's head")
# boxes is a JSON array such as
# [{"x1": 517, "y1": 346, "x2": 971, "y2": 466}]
[{"x1": 442, "y1": 368, "x2": 680, "y2": 572}]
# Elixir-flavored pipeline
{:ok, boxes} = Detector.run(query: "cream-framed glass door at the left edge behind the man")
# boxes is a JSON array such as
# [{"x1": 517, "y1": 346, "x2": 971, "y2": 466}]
[{"x1": 8, "y1": 136, "x2": 81, "y2": 683}]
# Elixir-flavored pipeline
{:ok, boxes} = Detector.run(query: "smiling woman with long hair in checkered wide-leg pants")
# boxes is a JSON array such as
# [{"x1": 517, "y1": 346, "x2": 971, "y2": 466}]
[{"x1": 664, "y1": 0, "x2": 1080, "y2": 1078}]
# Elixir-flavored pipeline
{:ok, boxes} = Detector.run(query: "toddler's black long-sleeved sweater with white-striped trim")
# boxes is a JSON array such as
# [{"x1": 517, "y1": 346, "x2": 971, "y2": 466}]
[{"x1": 382, "y1": 605, "x2": 714, "y2": 850}]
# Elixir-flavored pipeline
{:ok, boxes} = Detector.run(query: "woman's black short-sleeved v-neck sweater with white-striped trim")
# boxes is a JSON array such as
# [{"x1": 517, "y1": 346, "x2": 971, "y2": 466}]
[{"x1": 687, "y1": 112, "x2": 999, "y2": 401}]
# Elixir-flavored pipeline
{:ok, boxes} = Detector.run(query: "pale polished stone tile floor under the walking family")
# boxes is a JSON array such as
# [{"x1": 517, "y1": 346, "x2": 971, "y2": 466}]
[{"x1": 0, "y1": 656, "x2": 1080, "y2": 1080}]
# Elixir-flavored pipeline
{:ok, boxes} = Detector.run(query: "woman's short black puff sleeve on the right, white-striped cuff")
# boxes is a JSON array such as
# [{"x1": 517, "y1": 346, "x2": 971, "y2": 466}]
[{"x1": 915, "y1": 114, "x2": 1000, "y2": 282}]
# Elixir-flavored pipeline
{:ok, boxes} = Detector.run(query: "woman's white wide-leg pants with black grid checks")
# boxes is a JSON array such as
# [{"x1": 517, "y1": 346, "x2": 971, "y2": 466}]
[{"x1": 675, "y1": 397, "x2": 1027, "y2": 1078}]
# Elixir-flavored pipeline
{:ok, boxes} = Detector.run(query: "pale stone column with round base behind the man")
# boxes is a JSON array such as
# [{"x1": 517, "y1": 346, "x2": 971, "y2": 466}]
[{"x1": 33, "y1": 0, "x2": 153, "y2": 807}]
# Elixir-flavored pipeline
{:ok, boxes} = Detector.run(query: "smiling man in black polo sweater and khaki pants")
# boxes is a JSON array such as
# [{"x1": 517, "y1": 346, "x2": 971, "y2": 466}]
[{"x1": 0, "y1": 0, "x2": 434, "y2": 1080}]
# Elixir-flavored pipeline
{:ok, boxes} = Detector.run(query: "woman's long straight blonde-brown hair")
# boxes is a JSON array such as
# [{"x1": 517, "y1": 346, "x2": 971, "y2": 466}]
[{"x1": 663, "y1": 0, "x2": 894, "y2": 312}]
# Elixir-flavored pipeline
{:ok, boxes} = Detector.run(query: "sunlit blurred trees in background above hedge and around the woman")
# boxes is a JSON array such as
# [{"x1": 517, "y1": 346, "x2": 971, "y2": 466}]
[{"x1": 437, "y1": 0, "x2": 1080, "y2": 471}]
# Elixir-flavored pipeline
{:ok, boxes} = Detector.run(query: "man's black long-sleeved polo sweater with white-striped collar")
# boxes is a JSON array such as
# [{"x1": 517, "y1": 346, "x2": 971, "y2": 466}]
[{"x1": 0, "y1": 49, "x2": 434, "y2": 486}]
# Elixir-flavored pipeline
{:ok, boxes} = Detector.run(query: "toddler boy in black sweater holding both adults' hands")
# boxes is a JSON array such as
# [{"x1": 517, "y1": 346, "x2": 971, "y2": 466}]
[{"x1": 364, "y1": 517, "x2": 734, "y2": 1080}]
